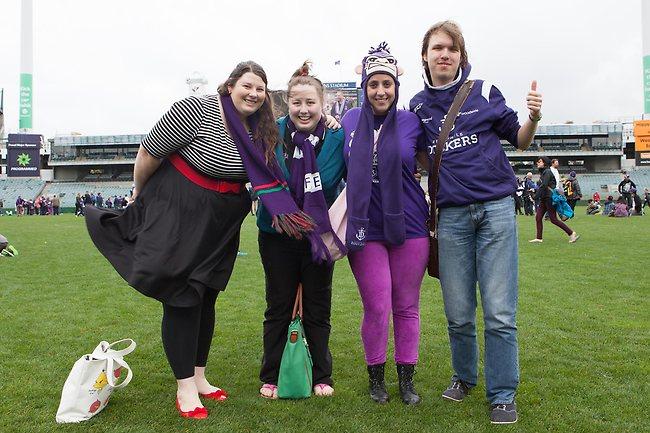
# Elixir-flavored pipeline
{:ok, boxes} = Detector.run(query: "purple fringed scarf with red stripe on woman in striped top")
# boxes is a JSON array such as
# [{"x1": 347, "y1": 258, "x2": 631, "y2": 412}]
[{"x1": 221, "y1": 95, "x2": 315, "y2": 239}]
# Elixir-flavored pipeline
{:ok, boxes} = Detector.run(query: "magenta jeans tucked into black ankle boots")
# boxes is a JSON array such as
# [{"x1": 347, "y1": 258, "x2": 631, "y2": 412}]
[{"x1": 348, "y1": 238, "x2": 429, "y2": 365}]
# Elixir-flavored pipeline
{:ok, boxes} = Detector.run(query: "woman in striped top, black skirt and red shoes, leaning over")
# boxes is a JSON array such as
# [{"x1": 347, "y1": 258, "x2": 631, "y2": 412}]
[{"x1": 86, "y1": 62, "x2": 278, "y2": 418}]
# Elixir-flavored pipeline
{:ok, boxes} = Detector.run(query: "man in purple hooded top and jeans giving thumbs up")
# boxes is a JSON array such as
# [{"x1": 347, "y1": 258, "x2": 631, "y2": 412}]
[{"x1": 410, "y1": 21, "x2": 542, "y2": 424}]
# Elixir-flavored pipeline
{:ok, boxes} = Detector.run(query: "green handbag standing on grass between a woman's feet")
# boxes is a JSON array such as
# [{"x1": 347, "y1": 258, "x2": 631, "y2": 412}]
[{"x1": 278, "y1": 284, "x2": 313, "y2": 399}]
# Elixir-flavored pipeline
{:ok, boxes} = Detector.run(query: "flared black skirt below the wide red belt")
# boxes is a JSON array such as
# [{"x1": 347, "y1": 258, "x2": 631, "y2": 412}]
[{"x1": 86, "y1": 161, "x2": 251, "y2": 307}]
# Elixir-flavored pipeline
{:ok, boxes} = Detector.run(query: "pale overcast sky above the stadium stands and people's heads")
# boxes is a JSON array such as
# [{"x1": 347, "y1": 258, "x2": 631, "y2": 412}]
[{"x1": 0, "y1": 0, "x2": 650, "y2": 137}]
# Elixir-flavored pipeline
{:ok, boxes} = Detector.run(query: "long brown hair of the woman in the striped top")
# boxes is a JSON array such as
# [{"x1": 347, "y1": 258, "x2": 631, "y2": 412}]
[{"x1": 217, "y1": 60, "x2": 278, "y2": 164}]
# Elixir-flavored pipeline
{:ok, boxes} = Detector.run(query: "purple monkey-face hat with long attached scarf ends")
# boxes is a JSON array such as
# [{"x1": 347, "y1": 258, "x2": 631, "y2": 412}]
[{"x1": 345, "y1": 43, "x2": 406, "y2": 251}]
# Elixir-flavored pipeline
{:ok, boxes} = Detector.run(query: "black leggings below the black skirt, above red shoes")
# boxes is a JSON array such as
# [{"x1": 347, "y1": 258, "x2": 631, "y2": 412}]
[{"x1": 162, "y1": 289, "x2": 219, "y2": 379}]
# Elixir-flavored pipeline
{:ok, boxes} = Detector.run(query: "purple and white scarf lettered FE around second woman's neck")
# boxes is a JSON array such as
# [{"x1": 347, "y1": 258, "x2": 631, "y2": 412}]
[{"x1": 287, "y1": 118, "x2": 345, "y2": 263}]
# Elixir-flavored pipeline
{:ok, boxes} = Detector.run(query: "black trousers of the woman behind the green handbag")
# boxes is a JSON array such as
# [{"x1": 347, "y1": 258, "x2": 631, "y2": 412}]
[{"x1": 258, "y1": 231, "x2": 334, "y2": 385}]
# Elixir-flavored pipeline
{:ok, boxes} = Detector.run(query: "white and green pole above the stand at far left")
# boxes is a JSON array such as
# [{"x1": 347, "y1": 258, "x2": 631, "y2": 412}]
[{"x1": 18, "y1": 0, "x2": 34, "y2": 132}]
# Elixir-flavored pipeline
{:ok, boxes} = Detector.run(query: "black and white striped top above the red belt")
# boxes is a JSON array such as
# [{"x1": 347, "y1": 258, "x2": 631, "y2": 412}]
[{"x1": 142, "y1": 95, "x2": 248, "y2": 180}]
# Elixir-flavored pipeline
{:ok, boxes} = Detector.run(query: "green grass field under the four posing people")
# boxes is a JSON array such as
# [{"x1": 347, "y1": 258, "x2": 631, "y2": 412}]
[{"x1": 0, "y1": 210, "x2": 650, "y2": 433}]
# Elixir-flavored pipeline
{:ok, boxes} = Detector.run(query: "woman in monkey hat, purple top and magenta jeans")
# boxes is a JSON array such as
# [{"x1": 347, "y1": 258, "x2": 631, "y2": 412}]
[{"x1": 342, "y1": 43, "x2": 429, "y2": 404}]
